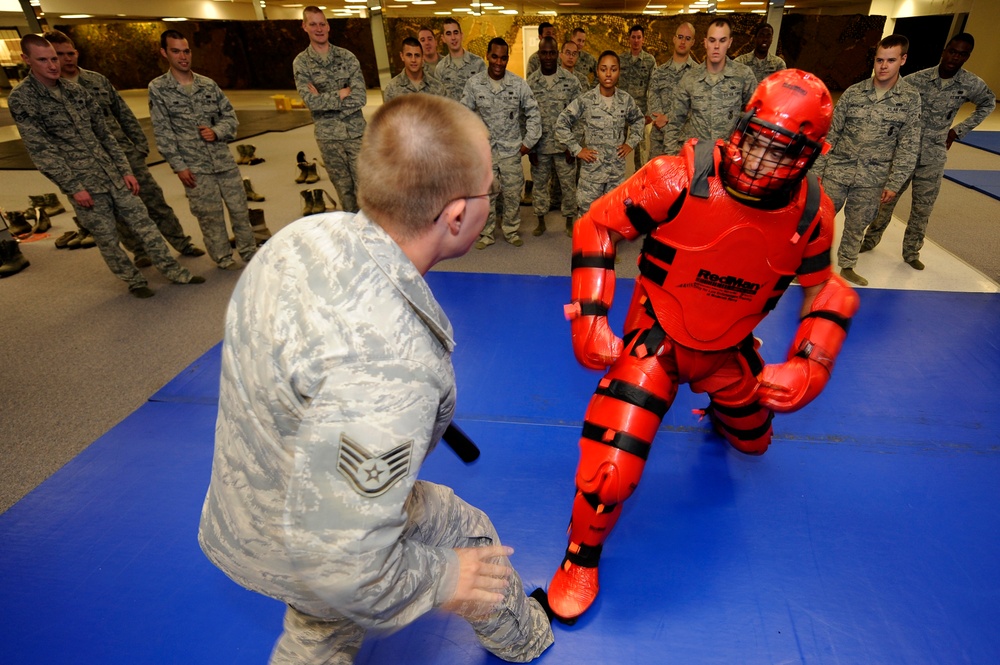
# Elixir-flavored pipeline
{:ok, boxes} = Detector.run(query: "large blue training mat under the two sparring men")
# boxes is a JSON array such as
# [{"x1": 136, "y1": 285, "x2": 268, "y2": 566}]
[{"x1": 0, "y1": 273, "x2": 1000, "y2": 665}]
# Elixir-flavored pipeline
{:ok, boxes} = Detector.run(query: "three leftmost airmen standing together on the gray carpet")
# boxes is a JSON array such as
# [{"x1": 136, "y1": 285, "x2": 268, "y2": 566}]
[{"x1": 8, "y1": 30, "x2": 270, "y2": 298}]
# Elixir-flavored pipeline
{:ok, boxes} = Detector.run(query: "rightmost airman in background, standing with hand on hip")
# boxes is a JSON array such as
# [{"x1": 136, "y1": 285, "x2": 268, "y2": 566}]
[{"x1": 861, "y1": 32, "x2": 997, "y2": 270}]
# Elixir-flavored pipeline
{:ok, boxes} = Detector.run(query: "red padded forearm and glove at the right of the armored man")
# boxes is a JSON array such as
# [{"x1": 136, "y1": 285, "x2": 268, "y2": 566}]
[{"x1": 757, "y1": 275, "x2": 859, "y2": 412}]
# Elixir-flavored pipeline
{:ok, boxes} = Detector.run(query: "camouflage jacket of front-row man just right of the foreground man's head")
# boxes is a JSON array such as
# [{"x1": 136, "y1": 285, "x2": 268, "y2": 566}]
[{"x1": 462, "y1": 71, "x2": 542, "y2": 157}]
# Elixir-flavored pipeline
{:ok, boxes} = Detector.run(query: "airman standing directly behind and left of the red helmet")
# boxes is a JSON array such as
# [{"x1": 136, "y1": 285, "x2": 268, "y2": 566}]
[{"x1": 663, "y1": 18, "x2": 757, "y2": 155}]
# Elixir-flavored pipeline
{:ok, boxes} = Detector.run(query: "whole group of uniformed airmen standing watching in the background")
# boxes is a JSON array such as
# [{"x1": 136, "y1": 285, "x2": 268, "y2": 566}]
[{"x1": 10, "y1": 6, "x2": 996, "y2": 297}]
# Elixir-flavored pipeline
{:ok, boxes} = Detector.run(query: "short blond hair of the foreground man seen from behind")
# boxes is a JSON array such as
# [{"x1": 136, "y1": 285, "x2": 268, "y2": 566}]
[{"x1": 357, "y1": 93, "x2": 490, "y2": 238}]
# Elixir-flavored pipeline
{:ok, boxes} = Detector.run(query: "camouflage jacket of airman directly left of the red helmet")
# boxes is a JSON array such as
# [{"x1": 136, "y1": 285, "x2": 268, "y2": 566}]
[{"x1": 663, "y1": 60, "x2": 757, "y2": 154}]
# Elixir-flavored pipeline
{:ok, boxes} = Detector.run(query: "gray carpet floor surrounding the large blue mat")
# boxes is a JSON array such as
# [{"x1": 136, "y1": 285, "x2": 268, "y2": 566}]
[{"x1": 0, "y1": 101, "x2": 1000, "y2": 512}]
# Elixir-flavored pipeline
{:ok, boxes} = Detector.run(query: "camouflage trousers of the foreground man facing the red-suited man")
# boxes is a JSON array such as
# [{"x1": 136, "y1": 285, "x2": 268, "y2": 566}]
[{"x1": 270, "y1": 480, "x2": 553, "y2": 665}]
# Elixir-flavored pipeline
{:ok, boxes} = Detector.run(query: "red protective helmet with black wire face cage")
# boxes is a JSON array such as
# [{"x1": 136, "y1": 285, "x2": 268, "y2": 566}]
[{"x1": 720, "y1": 69, "x2": 833, "y2": 198}]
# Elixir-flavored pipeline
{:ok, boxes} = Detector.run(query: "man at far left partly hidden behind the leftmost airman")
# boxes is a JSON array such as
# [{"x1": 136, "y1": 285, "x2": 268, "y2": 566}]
[{"x1": 42, "y1": 30, "x2": 205, "y2": 265}]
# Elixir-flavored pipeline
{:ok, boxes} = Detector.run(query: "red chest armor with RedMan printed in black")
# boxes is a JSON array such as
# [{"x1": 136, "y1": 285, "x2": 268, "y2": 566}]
[{"x1": 638, "y1": 143, "x2": 820, "y2": 351}]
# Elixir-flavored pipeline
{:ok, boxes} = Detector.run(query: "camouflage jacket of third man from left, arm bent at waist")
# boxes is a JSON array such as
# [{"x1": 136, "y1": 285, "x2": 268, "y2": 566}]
[{"x1": 149, "y1": 71, "x2": 239, "y2": 173}]
